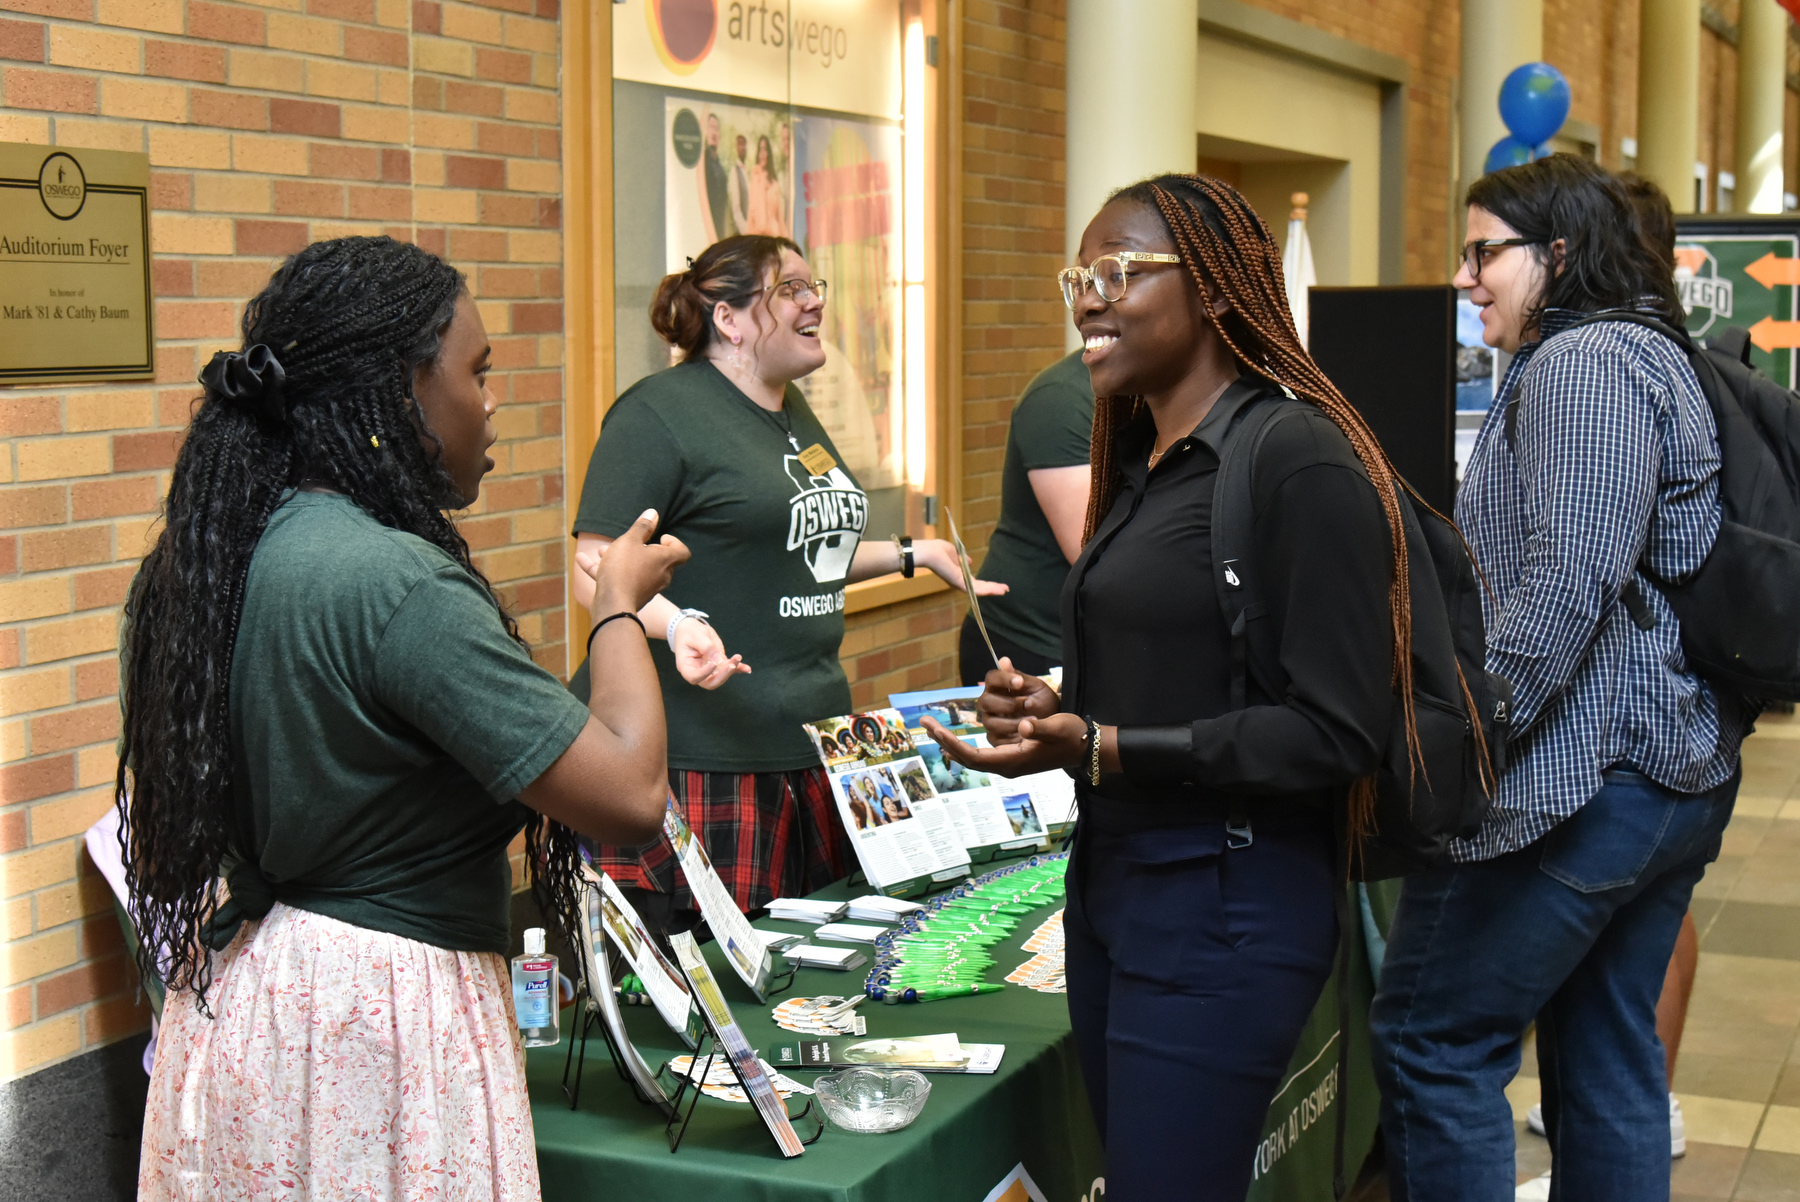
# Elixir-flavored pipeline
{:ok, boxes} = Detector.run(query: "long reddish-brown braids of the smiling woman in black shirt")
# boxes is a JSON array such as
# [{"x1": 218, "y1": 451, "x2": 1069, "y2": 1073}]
[{"x1": 1082, "y1": 175, "x2": 1418, "y2": 835}]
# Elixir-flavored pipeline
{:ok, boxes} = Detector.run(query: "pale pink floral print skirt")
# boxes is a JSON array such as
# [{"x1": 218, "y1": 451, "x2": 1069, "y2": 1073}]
[{"x1": 139, "y1": 903, "x2": 538, "y2": 1202}]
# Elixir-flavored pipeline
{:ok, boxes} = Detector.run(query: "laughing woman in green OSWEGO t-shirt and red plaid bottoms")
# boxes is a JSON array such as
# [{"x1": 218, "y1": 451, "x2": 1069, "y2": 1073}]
[{"x1": 569, "y1": 234, "x2": 1006, "y2": 930}]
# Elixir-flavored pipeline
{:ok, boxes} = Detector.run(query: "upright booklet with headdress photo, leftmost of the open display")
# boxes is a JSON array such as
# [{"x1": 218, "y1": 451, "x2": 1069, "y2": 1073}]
[{"x1": 806, "y1": 709, "x2": 968, "y2": 896}]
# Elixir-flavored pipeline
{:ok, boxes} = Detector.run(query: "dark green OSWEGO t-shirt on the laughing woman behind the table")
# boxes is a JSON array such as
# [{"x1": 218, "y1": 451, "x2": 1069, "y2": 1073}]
[{"x1": 569, "y1": 360, "x2": 869, "y2": 772}]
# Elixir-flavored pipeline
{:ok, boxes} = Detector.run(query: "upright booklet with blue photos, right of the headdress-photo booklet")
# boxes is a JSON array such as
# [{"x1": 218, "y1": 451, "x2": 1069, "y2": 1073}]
[{"x1": 887, "y1": 684, "x2": 1075, "y2": 864}]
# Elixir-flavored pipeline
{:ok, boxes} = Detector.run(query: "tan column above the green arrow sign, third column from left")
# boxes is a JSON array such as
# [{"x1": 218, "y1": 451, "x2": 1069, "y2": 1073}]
[{"x1": 1638, "y1": 0, "x2": 1699, "y2": 212}]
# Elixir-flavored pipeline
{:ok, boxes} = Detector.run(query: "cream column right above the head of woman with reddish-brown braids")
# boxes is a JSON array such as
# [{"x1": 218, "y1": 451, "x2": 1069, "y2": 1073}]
[{"x1": 1066, "y1": 0, "x2": 1201, "y2": 263}]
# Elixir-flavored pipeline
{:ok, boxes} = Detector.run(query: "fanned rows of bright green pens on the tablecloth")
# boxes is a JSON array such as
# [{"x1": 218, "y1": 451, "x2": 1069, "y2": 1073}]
[{"x1": 864, "y1": 853, "x2": 1069, "y2": 1006}]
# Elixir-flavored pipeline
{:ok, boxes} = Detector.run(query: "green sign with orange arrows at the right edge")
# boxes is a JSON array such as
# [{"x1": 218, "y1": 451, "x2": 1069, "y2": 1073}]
[{"x1": 1676, "y1": 216, "x2": 1800, "y2": 389}]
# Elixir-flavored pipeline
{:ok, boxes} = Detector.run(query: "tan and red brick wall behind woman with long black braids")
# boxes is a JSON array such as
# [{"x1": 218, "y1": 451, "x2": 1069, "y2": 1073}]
[{"x1": 0, "y1": 0, "x2": 563, "y2": 1080}]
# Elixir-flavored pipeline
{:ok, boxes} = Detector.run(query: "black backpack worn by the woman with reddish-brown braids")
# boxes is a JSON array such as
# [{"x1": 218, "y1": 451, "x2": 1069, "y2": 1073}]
[{"x1": 1213, "y1": 394, "x2": 1512, "y2": 880}]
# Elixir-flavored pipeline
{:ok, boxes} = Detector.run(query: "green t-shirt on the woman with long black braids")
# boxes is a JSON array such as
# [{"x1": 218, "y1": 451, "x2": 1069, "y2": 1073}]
[{"x1": 230, "y1": 493, "x2": 587, "y2": 954}]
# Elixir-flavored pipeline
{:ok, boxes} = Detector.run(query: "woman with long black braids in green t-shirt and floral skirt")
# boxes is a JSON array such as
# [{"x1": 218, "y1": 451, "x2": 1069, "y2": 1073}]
[{"x1": 119, "y1": 238, "x2": 686, "y2": 1200}]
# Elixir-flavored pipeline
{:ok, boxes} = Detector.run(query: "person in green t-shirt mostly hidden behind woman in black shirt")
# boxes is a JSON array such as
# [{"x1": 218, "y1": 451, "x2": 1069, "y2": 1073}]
[{"x1": 959, "y1": 351, "x2": 1094, "y2": 686}]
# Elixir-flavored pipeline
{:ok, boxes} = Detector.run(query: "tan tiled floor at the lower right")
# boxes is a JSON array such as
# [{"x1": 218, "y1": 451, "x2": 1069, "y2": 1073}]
[{"x1": 1507, "y1": 714, "x2": 1800, "y2": 1202}]
